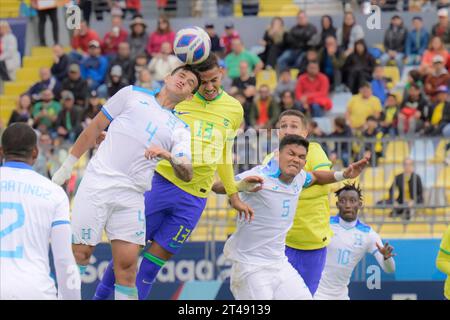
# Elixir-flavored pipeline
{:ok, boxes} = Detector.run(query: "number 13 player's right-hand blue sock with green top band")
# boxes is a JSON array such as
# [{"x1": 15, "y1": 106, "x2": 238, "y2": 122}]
[{"x1": 136, "y1": 252, "x2": 166, "y2": 300}]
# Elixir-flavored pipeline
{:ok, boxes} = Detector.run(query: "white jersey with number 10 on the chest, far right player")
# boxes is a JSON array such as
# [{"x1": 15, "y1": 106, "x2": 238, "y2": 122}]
[{"x1": 314, "y1": 216, "x2": 395, "y2": 300}]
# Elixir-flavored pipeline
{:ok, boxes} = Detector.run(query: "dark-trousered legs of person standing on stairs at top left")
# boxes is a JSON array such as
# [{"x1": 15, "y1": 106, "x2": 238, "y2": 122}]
[{"x1": 31, "y1": 0, "x2": 59, "y2": 47}]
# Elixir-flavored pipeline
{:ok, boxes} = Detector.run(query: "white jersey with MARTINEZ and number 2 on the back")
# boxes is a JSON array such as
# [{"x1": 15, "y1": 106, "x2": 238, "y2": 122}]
[{"x1": 0, "y1": 162, "x2": 71, "y2": 299}]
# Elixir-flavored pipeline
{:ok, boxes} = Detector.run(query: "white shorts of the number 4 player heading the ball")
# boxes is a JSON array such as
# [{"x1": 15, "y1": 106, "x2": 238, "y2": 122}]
[{"x1": 71, "y1": 174, "x2": 145, "y2": 246}]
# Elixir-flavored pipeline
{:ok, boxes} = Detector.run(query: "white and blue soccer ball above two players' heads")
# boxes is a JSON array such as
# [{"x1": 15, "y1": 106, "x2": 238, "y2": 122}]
[{"x1": 173, "y1": 27, "x2": 211, "y2": 64}]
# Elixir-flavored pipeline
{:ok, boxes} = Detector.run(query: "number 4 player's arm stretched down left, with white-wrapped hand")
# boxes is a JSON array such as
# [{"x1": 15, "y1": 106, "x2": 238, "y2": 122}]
[{"x1": 52, "y1": 112, "x2": 111, "y2": 185}]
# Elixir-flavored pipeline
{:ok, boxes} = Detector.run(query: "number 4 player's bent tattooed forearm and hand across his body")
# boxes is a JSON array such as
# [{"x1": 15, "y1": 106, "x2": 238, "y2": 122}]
[{"x1": 144, "y1": 146, "x2": 194, "y2": 182}]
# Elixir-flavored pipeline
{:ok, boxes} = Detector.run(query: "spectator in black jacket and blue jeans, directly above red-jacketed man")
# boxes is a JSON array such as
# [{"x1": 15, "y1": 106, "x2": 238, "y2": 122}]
[{"x1": 277, "y1": 11, "x2": 317, "y2": 70}]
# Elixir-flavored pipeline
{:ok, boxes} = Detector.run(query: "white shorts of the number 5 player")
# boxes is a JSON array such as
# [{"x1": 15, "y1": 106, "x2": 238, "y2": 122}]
[{"x1": 230, "y1": 259, "x2": 312, "y2": 300}]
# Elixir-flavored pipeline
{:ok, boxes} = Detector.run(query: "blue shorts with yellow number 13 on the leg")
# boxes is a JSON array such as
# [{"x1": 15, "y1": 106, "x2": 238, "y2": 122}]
[{"x1": 145, "y1": 172, "x2": 207, "y2": 254}]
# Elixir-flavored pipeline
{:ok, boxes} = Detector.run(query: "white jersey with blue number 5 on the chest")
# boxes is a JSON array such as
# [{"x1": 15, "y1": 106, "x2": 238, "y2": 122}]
[{"x1": 224, "y1": 166, "x2": 310, "y2": 266}]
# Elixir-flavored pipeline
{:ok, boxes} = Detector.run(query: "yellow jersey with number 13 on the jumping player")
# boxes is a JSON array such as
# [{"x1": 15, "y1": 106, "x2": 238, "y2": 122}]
[{"x1": 156, "y1": 91, "x2": 244, "y2": 198}]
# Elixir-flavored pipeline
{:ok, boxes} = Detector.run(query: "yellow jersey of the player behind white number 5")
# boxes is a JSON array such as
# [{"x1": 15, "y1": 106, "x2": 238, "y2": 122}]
[{"x1": 263, "y1": 142, "x2": 333, "y2": 250}]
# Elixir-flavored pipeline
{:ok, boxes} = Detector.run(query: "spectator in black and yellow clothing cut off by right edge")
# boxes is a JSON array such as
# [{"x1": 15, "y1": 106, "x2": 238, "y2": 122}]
[{"x1": 426, "y1": 86, "x2": 450, "y2": 138}]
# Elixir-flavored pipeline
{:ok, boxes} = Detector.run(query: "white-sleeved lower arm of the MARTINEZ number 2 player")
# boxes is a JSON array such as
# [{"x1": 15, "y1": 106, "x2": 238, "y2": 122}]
[{"x1": 51, "y1": 223, "x2": 81, "y2": 300}]
